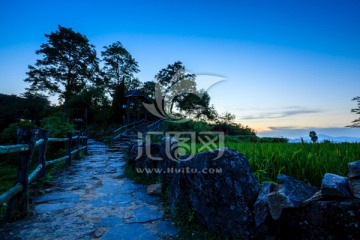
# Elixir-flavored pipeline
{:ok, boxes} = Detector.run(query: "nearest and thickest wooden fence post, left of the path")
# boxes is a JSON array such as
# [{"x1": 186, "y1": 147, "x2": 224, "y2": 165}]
[{"x1": 6, "y1": 129, "x2": 37, "y2": 219}]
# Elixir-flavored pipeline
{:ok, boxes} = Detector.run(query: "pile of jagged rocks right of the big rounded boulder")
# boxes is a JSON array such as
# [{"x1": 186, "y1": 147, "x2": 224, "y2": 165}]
[{"x1": 254, "y1": 161, "x2": 360, "y2": 239}]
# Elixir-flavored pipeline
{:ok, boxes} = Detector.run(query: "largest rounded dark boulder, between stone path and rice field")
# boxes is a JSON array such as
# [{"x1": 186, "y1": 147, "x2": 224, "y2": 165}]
[{"x1": 187, "y1": 148, "x2": 259, "y2": 239}]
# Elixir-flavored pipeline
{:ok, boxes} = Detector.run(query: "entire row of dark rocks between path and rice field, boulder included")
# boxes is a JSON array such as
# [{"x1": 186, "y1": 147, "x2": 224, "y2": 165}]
[{"x1": 129, "y1": 138, "x2": 360, "y2": 239}]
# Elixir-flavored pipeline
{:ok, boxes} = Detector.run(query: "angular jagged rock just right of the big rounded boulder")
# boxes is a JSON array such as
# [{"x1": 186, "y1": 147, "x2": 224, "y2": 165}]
[{"x1": 268, "y1": 174, "x2": 317, "y2": 220}]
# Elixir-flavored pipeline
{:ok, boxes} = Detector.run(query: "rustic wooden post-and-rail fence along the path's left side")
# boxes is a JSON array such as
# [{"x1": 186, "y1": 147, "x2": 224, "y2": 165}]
[{"x1": 0, "y1": 129, "x2": 88, "y2": 218}]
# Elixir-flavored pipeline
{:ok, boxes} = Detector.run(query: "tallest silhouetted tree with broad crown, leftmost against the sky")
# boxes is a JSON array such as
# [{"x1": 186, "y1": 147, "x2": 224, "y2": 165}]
[{"x1": 25, "y1": 25, "x2": 102, "y2": 104}]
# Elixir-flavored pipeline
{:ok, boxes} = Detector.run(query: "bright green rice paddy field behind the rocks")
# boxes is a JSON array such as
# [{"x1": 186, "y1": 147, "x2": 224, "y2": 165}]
[{"x1": 218, "y1": 142, "x2": 360, "y2": 186}]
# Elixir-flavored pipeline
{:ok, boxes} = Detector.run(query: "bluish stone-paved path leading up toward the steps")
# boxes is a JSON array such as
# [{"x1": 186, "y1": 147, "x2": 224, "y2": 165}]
[{"x1": 0, "y1": 140, "x2": 177, "y2": 240}]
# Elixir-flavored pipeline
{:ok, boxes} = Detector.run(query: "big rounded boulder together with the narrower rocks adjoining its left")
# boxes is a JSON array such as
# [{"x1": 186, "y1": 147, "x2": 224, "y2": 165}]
[{"x1": 161, "y1": 138, "x2": 259, "y2": 239}]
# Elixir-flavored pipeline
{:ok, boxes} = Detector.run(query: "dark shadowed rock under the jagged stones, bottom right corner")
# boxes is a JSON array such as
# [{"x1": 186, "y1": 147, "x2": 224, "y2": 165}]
[{"x1": 257, "y1": 199, "x2": 360, "y2": 240}]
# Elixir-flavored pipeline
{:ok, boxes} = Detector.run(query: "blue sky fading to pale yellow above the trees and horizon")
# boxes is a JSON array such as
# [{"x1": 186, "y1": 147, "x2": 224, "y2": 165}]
[{"x1": 0, "y1": 0, "x2": 360, "y2": 137}]
